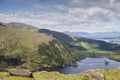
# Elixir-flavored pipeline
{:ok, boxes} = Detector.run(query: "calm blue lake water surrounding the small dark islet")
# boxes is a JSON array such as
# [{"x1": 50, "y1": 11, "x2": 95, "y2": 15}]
[{"x1": 56, "y1": 58, "x2": 120, "y2": 74}]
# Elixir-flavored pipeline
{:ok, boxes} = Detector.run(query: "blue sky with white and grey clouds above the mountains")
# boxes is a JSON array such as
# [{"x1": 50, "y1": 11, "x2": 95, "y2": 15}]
[{"x1": 0, "y1": 0, "x2": 120, "y2": 33}]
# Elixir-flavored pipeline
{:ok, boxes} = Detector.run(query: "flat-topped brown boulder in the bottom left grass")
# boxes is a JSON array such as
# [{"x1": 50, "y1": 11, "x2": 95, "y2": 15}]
[{"x1": 9, "y1": 69, "x2": 32, "y2": 76}]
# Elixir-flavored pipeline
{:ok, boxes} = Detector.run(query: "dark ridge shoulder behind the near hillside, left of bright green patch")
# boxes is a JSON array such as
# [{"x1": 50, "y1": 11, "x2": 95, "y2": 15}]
[{"x1": 38, "y1": 29, "x2": 85, "y2": 50}]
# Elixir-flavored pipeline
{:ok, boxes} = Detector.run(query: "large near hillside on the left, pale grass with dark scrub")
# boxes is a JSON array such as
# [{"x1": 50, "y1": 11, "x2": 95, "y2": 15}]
[{"x1": 0, "y1": 26, "x2": 73, "y2": 70}]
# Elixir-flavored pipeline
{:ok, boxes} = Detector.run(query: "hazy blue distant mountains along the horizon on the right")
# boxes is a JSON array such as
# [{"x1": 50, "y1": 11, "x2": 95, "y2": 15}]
[{"x1": 64, "y1": 31, "x2": 120, "y2": 39}]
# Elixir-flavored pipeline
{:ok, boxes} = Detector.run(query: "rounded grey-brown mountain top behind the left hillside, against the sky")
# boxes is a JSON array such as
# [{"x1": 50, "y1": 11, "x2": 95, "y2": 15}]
[{"x1": 0, "y1": 22, "x2": 38, "y2": 31}]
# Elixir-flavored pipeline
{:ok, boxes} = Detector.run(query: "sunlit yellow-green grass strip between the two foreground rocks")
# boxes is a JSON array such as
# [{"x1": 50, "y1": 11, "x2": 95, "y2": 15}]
[{"x1": 33, "y1": 71, "x2": 93, "y2": 80}]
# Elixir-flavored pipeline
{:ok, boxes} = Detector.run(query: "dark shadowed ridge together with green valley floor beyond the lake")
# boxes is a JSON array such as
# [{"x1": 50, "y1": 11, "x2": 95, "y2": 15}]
[{"x1": 39, "y1": 29, "x2": 120, "y2": 61}]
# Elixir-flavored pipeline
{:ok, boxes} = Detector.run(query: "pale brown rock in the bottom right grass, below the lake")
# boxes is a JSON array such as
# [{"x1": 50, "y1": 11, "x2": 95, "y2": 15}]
[{"x1": 83, "y1": 70, "x2": 105, "y2": 80}]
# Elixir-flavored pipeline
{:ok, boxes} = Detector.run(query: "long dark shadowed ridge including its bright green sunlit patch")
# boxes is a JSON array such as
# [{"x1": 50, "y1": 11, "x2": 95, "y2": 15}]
[{"x1": 39, "y1": 29, "x2": 120, "y2": 51}]
